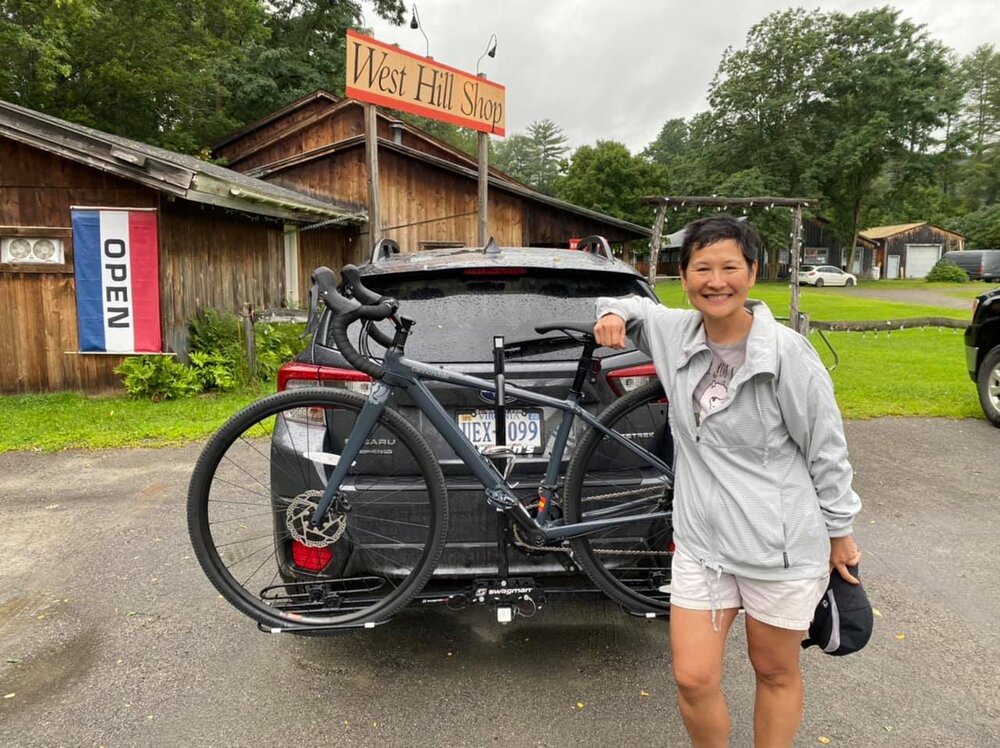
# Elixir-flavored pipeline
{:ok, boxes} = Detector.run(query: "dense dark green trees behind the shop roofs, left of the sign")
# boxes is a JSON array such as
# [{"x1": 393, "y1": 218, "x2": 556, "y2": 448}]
[{"x1": 0, "y1": 0, "x2": 404, "y2": 153}]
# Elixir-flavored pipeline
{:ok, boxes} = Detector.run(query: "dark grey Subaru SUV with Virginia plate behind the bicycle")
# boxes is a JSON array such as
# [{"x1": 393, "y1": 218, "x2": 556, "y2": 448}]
[{"x1": 275, "y1": 237, "x2": 671, "y2": 601}]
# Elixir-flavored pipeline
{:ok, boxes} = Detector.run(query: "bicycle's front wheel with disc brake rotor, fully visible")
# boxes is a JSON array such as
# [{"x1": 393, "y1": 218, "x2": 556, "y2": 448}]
[{"x1": 187, "y1": 387, "x2": 448, "y2": 630}]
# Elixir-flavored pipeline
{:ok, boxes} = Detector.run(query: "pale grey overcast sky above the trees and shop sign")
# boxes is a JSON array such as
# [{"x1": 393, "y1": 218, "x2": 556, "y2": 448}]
[{"x1": 366, "y1": 0, "x2": 1000, "y2": 153}]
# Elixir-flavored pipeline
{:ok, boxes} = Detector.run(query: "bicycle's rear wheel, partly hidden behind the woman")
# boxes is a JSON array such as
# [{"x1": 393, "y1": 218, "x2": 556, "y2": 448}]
[{"x1": 564, "y1": 381, "x2": 673, "y2": 614}]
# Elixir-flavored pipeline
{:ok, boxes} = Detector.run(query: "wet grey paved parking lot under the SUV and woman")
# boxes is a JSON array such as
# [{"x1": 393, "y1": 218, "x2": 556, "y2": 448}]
[{"x1": 0, "y1": 419, "x2": 1000, "y2": 748}]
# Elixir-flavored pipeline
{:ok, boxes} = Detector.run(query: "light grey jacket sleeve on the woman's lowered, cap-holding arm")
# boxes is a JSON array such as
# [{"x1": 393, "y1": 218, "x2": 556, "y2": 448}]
[{"x1": 775, "y1": 333, "x2": 861, "y2": 538}]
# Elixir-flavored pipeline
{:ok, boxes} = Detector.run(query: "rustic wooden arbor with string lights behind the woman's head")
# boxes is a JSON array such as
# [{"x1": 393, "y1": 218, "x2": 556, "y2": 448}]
[{"x1": 641, "y1": 195, "x2": 819, "y2": 334}]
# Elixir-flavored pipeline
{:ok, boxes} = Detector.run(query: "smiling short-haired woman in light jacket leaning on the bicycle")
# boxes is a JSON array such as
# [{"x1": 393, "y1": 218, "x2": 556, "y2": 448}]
[{"x1": 594, "y1": 215, "x2": 861, "y2": 746}]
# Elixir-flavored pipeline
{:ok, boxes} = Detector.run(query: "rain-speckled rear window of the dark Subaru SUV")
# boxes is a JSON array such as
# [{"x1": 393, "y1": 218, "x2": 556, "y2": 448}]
[{"x1": 330, "y1": 268, "x2": 645, "y2": 363}]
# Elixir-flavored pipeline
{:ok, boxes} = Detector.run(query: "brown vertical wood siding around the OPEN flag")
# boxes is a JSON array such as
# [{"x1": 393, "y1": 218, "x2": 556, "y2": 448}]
[{"x1": 0, "y1": 137, "x2": 360, "y2": 393}]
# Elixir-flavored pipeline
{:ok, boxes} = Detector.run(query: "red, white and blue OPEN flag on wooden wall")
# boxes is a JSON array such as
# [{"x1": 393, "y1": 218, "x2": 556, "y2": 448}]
[{"x1": 72, "y1": 208, "x2": 160, "y2": 353}]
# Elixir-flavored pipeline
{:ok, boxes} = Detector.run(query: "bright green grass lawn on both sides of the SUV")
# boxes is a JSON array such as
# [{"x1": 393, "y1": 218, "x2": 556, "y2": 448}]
[{"x1": 0, "y1": 281, "x2": 984, "y2": 452}]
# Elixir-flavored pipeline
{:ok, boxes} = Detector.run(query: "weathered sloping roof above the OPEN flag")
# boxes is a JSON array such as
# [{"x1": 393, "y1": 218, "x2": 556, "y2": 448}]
[{"x1": 0, "y1": 100, "x2": 368, "y2": 223}]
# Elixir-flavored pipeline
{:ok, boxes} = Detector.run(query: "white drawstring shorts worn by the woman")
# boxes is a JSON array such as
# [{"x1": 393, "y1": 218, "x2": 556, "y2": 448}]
[{"x1": 670, "y1": 551, "x2": 830, "y2": 631}]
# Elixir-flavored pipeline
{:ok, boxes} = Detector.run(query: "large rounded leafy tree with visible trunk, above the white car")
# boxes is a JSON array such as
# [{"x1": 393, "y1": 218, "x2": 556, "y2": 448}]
[{"x1": 709, "y1": 8, "x2": 960, "y2": 262}]
